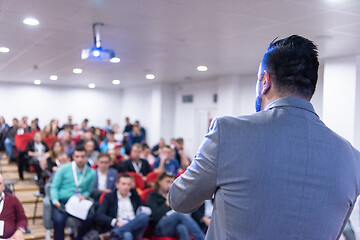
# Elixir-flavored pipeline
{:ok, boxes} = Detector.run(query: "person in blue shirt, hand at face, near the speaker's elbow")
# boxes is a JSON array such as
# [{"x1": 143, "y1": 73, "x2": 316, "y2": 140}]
[{"x1": 154, "y1": 145, "x2": 180, "y2": 175}]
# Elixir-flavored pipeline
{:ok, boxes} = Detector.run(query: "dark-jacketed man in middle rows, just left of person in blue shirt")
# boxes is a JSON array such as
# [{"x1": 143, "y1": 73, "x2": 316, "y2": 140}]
[{"x1": 124, "y1": 143, "x2": 152, "y2": 180}]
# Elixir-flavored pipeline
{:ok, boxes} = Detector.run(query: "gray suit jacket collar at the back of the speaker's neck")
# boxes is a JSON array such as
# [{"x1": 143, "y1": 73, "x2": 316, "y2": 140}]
[{"x1": 264, "y1": 97, "x2": 319, "y2": 117}]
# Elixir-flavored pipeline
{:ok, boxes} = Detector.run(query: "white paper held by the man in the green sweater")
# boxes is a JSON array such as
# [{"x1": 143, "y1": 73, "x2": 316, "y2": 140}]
[{"x1": 65, "y1": 195, "x2": 93, "y2": 220}]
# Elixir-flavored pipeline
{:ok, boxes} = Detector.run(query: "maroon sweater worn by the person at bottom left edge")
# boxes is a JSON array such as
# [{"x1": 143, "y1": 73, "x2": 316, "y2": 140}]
[{"x1": 0, "y1": 193, "x2": 27, "y2": 238}]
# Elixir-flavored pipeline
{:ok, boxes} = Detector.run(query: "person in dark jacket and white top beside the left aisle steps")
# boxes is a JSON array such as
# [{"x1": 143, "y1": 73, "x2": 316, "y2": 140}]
[{"x1": 26, "y1": 132, "x2": 49, "y2": 180}]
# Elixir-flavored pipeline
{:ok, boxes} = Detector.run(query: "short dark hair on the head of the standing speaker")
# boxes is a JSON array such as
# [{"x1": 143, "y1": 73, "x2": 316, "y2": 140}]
[{"x1": 262, "y1": 35, "x2": 319, "y2": 98}]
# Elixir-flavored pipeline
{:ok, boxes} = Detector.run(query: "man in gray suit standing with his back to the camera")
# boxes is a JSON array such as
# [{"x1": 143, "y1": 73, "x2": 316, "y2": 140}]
[{"x1": 169, "y1": 36, "x2": 360, "y2": 240}]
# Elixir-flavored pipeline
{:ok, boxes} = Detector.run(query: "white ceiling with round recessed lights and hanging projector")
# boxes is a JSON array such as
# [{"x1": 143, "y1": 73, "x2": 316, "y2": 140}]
[{"x1": 0, "y1": 0, "x2": 360, "y2": 89}]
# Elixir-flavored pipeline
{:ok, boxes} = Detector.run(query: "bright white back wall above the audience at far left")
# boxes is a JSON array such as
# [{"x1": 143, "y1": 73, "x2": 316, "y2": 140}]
[{"x1": 0, "y1": 84, "x2": 123, "y2": 127}]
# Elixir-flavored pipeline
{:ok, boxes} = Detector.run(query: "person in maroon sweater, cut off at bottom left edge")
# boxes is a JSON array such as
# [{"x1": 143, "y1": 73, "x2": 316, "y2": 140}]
[{"x1": 0, "y1": 174, "x2": 27, "y2": 240}]
